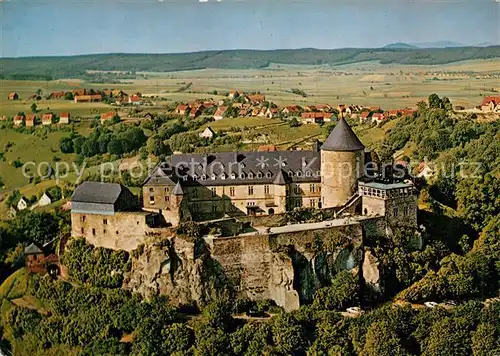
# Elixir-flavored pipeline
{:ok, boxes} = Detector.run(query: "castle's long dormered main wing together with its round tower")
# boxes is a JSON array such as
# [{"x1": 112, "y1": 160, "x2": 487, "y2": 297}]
[{"x1": 143, "y1": 119, "x2": 414, "y2": 225}]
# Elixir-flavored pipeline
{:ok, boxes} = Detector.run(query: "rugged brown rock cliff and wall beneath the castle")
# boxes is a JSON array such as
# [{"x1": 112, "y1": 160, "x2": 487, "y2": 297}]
[{"x1": 124, "y1": 221, "x2": 380, "y2": 310}]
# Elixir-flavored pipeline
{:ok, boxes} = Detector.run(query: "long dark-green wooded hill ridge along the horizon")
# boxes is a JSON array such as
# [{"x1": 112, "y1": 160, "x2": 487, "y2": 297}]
[{"x1": 0, "y1": 46, "x2": 500, "y2": 80}]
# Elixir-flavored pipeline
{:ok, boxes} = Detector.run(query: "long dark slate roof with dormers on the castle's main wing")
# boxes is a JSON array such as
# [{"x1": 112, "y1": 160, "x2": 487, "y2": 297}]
[{"x1": 145, "y1": 151, "x2": 321, "y2": 187}]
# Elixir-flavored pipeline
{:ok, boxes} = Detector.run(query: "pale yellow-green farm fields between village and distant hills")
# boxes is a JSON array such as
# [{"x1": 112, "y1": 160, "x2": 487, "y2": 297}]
[{"x1": 0, "y1": 59, "x2": 500, "y2": 115}]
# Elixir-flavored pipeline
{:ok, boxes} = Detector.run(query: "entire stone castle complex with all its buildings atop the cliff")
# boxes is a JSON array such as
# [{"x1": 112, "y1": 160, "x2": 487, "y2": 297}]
[{"x1": 72, "y1": 119, "x2": 417, "y2": 248}]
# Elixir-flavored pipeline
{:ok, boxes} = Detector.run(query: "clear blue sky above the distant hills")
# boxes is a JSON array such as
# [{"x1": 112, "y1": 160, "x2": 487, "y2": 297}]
[{"x1": 0, "y1": 0, "x2": 500, "y2": 57}]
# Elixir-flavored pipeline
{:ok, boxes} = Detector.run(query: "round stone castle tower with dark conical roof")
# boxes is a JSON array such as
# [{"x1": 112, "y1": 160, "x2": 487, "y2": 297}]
[{"x1": 321, "y1": 118, "x2": 365, "y2": 208}]
